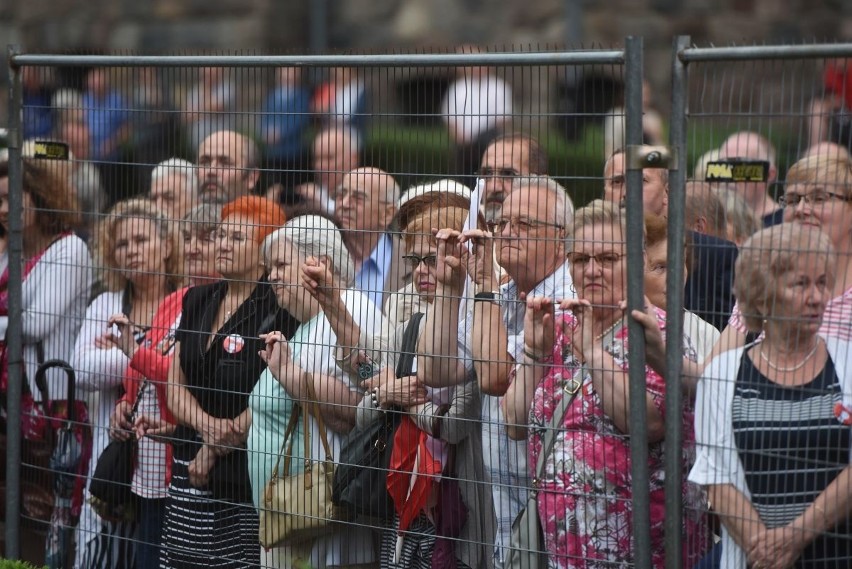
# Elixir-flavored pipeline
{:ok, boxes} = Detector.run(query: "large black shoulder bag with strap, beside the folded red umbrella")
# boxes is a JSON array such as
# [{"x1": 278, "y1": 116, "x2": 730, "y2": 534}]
[{"x1": 331, "y1": 312, "x2": 423, "y2": 520}]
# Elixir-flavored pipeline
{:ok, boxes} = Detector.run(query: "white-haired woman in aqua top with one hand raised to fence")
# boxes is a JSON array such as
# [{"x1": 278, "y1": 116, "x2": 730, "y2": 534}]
[{"x1": 248, "y1": 215, "x2": 384, "y2": 569}]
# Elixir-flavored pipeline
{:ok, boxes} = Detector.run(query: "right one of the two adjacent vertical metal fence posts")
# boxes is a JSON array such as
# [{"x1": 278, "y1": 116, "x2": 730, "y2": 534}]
[{"x1": 665, "y1": 36, "x2": 691, "y2": 569}]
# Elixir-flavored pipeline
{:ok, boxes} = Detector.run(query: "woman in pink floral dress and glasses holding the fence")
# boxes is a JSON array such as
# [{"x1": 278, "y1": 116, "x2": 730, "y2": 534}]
[{"x1": 503, "y1": 200, "x2": 702, "y2": 567}]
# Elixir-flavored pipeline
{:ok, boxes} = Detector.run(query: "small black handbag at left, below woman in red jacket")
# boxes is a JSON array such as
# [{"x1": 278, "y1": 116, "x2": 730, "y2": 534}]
[{"x1": 89, "y1": 380, "x2": 148, "y2": 521}]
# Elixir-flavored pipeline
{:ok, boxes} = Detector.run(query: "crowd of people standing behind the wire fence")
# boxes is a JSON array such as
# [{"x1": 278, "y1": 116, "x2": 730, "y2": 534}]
[{"x1": 0, "y1": 58, "x2": 852, "y2": 569}]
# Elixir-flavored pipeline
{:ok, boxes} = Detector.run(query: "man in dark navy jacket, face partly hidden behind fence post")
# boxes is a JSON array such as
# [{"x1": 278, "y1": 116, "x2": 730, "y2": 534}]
[{"x1": 604, "y1": 144, "x2": 737, "y2": 329}]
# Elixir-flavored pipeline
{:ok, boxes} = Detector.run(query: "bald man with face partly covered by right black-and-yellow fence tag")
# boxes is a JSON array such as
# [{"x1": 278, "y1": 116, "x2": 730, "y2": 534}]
[{"x1": 719, "y1": 131, "x2": 784, "y2": 227}]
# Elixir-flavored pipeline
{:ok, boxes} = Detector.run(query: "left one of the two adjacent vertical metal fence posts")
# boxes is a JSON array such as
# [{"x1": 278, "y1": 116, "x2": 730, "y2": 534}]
[{"x1": 624, "y1": 37, "x2": 651, "y2": 569}]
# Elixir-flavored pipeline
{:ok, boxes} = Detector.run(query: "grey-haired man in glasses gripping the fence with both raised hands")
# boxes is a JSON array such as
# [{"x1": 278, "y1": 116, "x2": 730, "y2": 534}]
[{"x1": 417, "y1": 176, "x2": 576, "y2": 567}]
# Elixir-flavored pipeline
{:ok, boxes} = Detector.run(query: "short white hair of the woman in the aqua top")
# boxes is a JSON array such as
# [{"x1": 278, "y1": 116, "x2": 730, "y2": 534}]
[{"x1": 261, "y1": 215, "x2": 355, "y2": 287}]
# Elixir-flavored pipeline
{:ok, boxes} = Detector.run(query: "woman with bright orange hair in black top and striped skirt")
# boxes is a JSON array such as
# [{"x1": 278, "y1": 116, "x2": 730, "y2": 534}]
[{"x1": 160, "y1": 196, "x2": 298, "y2": 569}]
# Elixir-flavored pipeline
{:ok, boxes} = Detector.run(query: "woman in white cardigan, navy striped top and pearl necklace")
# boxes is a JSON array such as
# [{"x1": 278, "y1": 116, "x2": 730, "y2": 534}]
[{"x1": 689, "y1": 223, "x2": 852, "y2": 569}]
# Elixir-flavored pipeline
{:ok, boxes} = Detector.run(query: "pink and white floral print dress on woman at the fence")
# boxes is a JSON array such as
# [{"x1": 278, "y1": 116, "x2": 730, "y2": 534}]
[{"x1": 528, "y1": 310, "x2": 707, "y2": 568}]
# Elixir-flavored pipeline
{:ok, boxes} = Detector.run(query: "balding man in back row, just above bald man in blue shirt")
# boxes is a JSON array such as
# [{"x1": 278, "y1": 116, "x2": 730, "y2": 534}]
[{"x1": 312, "y1": 126, "x2": 361, "y2": 213}]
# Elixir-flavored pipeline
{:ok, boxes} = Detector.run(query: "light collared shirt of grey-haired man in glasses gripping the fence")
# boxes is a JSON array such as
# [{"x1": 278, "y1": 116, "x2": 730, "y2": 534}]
[{"x1": 480, "y1": 261, "x2": 577, "y2": 567}]
